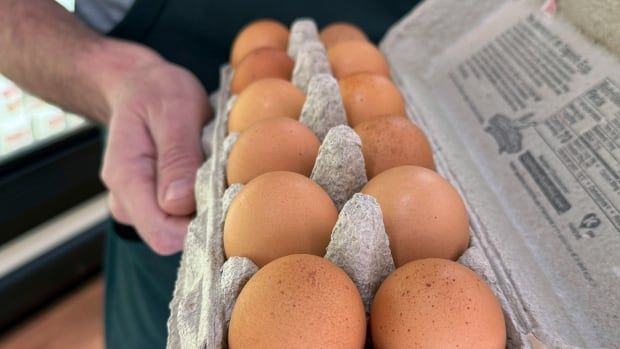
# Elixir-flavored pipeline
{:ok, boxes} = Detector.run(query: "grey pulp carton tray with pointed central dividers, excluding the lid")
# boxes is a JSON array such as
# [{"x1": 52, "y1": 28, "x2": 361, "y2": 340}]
[{"x1": 167, "y1": 19, "x2": 522, "y2": 348}]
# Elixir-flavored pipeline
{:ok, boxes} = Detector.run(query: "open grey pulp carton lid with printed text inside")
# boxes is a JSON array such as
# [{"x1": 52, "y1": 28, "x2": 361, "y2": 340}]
[{"x1": 381, "y1": 0, "x2": 620, "y2": 348}]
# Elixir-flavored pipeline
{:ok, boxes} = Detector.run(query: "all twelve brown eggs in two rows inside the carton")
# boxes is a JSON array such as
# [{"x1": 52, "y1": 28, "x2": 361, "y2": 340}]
[{"x1": 216, "y1": 20, "x2": 506, "y2": 348}]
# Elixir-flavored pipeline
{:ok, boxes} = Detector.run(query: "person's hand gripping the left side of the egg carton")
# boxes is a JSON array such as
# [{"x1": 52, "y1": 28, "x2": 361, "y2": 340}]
[{"x1": 101, "y1": 59, "x2": 211, "y2": 255}]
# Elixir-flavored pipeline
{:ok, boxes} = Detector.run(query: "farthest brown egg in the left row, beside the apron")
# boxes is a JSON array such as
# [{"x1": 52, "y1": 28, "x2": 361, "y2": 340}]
[{"x1": 230, "y1": 19, "x2": 289, "y2": 67}]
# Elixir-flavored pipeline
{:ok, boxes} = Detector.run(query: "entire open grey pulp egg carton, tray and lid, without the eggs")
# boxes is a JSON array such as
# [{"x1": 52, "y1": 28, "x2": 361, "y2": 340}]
[{"x1": 168, "y1": 0, "x2": 620, "y2": 348}]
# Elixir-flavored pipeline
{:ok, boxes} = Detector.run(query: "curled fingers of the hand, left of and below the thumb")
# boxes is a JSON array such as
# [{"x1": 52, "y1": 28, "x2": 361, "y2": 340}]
[{"x1": 102, "y1": 116, "x2": 189, "y2": 255}]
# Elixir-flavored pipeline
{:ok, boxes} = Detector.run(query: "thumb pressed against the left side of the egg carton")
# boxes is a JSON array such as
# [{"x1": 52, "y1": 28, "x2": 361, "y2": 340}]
[{"x1": 155, "y1": 118, "x2": 204, "y2": 216}]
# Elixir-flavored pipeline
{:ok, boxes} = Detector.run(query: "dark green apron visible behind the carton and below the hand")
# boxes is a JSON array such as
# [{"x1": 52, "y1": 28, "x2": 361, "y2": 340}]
[{"x1": 105, "y1": 0, "x2": 418, "y2": 349}]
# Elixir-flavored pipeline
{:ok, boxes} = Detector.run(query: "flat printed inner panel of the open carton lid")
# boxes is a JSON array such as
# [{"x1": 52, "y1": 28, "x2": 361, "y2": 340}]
[{"x1": 426, "y1": 1, "x2": 620, "y2": 342}]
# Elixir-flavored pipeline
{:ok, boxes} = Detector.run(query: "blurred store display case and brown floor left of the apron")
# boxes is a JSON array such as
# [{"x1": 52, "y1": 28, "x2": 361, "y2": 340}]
[{"x1": 0, "y1": 0, "x2": 108, "y2": 349}]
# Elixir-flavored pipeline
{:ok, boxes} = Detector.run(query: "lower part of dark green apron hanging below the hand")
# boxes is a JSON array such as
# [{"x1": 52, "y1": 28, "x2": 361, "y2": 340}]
[{"x1": 104, "y1": 222, "x2": 180, "y2": 349}]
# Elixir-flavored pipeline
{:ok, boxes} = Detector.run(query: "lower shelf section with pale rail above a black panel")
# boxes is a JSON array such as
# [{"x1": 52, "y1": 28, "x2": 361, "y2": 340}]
[{"x1": 0, "y1": 194, "x2": 108, "y2": 330}]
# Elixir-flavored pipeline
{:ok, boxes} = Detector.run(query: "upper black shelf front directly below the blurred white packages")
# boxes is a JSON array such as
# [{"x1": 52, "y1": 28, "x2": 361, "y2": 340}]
[{"x1": 0, "y1": 125, "x2": 104, "y2": 246}]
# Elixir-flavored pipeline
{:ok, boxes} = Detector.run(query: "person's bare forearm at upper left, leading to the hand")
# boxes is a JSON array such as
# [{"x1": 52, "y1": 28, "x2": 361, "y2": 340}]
[{"x1": 0, "y1": 0, "x2": 161, "y2": 123}]
